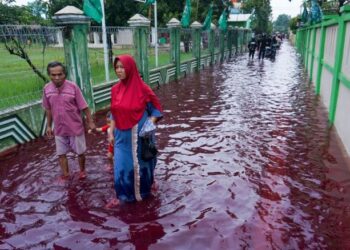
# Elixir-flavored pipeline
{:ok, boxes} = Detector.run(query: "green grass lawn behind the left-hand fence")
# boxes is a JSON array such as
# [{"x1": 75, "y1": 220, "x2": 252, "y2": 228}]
[{"x1": 0, "y1": 44, "x2": 197, "y2": 110}]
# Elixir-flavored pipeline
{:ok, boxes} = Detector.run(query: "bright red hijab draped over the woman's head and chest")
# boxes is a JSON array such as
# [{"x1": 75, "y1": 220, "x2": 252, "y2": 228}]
[{"x1": 111, "y1": 55, "x2": 162, "y2": 130}]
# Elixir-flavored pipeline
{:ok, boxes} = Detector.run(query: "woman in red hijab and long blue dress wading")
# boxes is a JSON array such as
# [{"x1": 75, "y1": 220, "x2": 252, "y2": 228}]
[{"x1": 109, "y1": 55, "x2": 163, "y2": 205}]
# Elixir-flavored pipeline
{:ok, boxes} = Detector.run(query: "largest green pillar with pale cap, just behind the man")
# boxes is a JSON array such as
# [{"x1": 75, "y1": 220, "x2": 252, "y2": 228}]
[{"x1": 53, "y1": 6, "x2": 95, "y2": 112}]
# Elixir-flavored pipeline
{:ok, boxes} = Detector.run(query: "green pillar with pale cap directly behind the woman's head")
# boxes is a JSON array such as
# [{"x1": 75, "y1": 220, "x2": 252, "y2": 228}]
[{"x1": 128, "y1": 14, "x2": 150, "y2": 84}]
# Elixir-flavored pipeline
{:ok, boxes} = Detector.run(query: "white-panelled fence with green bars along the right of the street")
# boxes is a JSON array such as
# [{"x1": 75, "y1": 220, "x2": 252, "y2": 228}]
[{"x1": 296, "y1": 5, "x2": 350, "y2": 153}]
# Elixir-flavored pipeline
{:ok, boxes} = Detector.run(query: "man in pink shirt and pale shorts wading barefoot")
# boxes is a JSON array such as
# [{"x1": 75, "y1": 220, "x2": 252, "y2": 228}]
[{"x1": 42, "y1": 62, "x2": 96, "y2": 180}]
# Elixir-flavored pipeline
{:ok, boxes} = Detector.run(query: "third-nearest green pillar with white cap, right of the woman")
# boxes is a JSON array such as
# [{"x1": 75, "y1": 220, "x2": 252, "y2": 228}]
[{"x1": 167, "y1": 18, "x2": 181, "y2": 80}]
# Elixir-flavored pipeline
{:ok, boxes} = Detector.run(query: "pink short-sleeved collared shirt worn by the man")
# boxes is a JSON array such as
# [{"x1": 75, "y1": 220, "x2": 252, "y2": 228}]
[{"x1": 43, "y1": 80, "x2": 88, "y2": 136}]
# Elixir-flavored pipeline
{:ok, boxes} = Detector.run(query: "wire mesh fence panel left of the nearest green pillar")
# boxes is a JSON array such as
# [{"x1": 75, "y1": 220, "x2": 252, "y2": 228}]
[{"x1": 0, "y1": 25, "x2": 64, "y2": 110}]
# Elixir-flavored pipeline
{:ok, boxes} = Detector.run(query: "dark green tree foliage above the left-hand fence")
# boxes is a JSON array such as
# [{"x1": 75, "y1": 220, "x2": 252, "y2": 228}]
[{"x1": 0, "y1": 0, "x2": 227, "y2": 27}]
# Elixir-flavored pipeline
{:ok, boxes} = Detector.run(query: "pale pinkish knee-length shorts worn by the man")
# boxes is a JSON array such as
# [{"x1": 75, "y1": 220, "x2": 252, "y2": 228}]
[{"x1": 55, "y1": 134, "x2": 86, "y2": 155}]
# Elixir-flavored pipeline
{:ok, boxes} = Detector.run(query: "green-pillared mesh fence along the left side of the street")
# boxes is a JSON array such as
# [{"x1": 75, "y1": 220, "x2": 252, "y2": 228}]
[{"x1": 0, "y1": 15, "x2": 252, "y2": 151}]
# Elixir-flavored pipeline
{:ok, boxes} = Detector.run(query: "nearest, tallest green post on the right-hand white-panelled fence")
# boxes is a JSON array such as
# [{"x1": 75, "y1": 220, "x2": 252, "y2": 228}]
[{"x1": 329, "y1": 6, "x2": 350, "y2": 125}]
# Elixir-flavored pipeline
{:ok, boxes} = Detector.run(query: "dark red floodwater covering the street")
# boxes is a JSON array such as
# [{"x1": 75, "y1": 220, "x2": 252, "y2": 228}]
[{"x1": 0, "y1": 42, "x2": 350, "y2": 250}]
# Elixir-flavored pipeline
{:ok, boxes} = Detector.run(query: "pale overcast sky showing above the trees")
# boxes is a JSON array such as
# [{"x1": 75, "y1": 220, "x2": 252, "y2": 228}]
[{"x1": 16, "y1": 0, "x2": 303, "y2": 20}]
